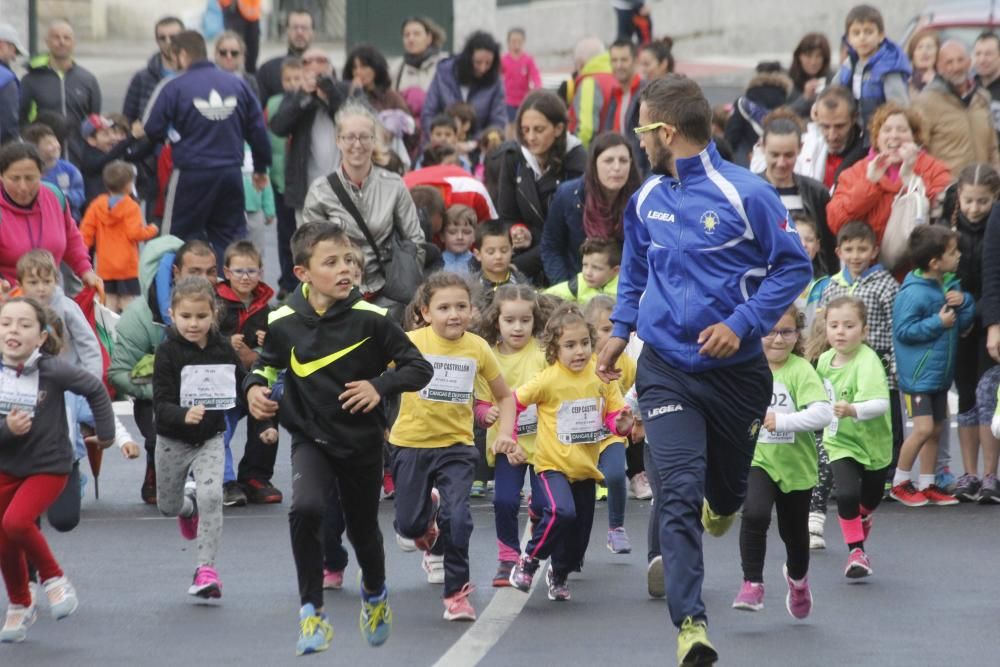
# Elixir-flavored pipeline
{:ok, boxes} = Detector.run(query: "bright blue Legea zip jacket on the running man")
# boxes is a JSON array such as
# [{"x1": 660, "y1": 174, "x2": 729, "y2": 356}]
[{"x1": 611, "y1": 142, "x2": 812, "y2": 372}]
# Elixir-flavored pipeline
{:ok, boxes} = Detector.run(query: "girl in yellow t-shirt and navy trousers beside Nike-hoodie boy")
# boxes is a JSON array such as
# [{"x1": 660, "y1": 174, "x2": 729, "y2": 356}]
[{"x1": 389, "y1": 272, "x2": 524, "y2": 621}]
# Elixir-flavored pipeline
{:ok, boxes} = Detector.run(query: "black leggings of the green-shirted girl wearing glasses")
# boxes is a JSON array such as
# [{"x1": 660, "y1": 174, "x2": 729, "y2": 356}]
[{"x1": 740, "y1": 467, "x2": 812, "y2": 584}]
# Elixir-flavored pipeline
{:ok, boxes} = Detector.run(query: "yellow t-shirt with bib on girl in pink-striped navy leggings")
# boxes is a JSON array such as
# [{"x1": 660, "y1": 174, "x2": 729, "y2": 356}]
[{"x1": 514, "y1": 359, "x2": 625, "y2": 482}]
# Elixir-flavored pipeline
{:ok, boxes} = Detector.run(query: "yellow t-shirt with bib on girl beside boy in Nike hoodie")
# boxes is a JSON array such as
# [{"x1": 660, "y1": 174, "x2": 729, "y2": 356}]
[{"x1": 389, "y1": 327, "x2": 500, "y2": 449}]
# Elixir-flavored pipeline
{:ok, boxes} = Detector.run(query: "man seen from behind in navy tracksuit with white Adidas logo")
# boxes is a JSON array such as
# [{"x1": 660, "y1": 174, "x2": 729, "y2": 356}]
[{"x1": 142, "y1": 30, "x2": 271, "y2": 271}]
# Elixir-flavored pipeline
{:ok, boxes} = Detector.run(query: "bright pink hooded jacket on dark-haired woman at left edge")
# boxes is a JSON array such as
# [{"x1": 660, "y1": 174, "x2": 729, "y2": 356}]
[{"x1": 0, "y1": 185, "x2": 93, "y2": 285}]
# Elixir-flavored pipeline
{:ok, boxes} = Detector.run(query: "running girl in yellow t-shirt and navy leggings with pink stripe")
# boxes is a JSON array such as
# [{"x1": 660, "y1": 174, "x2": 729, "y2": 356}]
[{"x1": 510, "y1": 304, "x2": 633, "y2": 600}]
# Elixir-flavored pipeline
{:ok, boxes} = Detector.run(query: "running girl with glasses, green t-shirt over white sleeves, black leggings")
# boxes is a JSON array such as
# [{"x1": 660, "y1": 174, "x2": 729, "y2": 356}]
[{"x1": 733, "y1": 306, "x2": 833, "y2": 618}]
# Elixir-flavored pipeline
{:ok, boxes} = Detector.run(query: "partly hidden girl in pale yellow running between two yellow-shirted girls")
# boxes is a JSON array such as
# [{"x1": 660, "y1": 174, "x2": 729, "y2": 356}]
[{"x1": 476, "y1": 285, "x2": 548, "y2": 588}]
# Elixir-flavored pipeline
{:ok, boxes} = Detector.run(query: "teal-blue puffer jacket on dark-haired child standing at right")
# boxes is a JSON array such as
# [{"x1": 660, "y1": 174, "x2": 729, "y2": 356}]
[{"x1": 892, "y1": 269, "x2": 976, "y2": 394}]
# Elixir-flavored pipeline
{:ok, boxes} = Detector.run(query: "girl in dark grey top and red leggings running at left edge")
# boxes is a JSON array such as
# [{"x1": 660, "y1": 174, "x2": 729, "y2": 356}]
[{"x1": 0, "y1": 297, "x2": 115, "y2": 642}]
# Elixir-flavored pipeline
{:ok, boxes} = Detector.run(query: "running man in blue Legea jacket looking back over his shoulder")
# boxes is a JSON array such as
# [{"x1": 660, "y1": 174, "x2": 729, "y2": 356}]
[{"x1": 598, "y1": 75, "x2": 812, "y2": 665}]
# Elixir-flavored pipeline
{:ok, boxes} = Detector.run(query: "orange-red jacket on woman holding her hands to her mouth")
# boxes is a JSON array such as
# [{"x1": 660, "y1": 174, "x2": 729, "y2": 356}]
[{"x1": 826, "y1": 150, "x2": 951, "y2": 243}]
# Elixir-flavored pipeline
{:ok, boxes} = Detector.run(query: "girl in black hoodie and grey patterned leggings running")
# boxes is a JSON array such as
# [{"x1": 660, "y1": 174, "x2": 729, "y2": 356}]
[{"x1": 153, "y1": 278, "x2": 245, "y2": 599}]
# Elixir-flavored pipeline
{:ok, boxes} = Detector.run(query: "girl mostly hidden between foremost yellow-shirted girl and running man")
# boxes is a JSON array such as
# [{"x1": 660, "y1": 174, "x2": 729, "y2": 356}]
[{"x1": 583, "y1": 294, "x2": 636, "y2": 554}]
